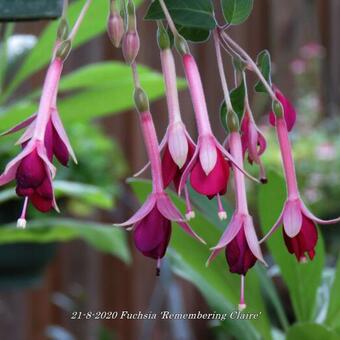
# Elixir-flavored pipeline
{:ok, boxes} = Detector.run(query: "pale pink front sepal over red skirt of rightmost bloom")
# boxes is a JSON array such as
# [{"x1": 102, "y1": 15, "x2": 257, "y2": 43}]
[{"x1": 283, "y1": 200, "x2": 302, "y2": 237}]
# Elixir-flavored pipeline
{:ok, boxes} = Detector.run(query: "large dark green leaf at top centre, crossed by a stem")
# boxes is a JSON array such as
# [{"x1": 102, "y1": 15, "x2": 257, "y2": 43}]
[{"x1": 145, "y1": 0, "x2": 216, "y2": 42}]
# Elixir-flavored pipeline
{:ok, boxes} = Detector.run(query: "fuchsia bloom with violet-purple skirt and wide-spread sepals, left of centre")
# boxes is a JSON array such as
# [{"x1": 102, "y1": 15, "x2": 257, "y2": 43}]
[{"x1": 117, "y1": 89, "x2": 205, "y2": 274}]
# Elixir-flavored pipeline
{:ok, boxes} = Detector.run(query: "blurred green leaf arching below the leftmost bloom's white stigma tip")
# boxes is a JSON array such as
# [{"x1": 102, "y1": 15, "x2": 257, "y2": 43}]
[{"x1": 0, "y1": 218, "x2": 130, "y2": 263}]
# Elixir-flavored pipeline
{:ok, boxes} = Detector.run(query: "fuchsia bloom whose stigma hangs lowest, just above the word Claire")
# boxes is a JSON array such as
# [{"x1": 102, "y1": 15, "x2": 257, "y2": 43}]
[{"x1": 207, "y1": 131, "x2": 266, "y2": 310}]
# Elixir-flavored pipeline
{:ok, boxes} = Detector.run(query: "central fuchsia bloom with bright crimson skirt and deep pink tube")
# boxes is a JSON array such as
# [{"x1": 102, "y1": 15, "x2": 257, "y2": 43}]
[{"x1": 179, "y1": 53, "x2": 256, "y2": 219}]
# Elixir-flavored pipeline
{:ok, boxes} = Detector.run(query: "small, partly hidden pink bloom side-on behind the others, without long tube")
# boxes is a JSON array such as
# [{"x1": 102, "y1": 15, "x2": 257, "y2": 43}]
[{"x1": 241, "y1": 110, "x2": 267, "y2": 183}]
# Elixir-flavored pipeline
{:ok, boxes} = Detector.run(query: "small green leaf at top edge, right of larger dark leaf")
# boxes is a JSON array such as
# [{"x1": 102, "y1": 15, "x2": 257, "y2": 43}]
[{"x1": 221, "y1": 0, "x2": 254, "y2": 25}]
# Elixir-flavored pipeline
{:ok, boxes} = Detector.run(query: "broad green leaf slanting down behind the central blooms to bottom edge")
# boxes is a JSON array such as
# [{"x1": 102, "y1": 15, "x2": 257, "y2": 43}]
[{"x1": 130, "y1": 180, "x2": 271, "y2": 339}]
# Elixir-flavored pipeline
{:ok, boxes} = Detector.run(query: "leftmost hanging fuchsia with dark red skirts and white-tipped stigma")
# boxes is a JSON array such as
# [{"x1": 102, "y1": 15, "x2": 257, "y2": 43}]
[{"x1": 0, "y1": 58, "x2": 75, "y2": 227}]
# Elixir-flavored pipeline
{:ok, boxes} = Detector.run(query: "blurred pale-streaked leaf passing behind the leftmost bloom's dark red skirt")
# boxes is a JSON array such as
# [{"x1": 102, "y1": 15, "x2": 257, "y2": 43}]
[{"x1": 0, "y1": 180, "x2": 113, "y2": 209}]
